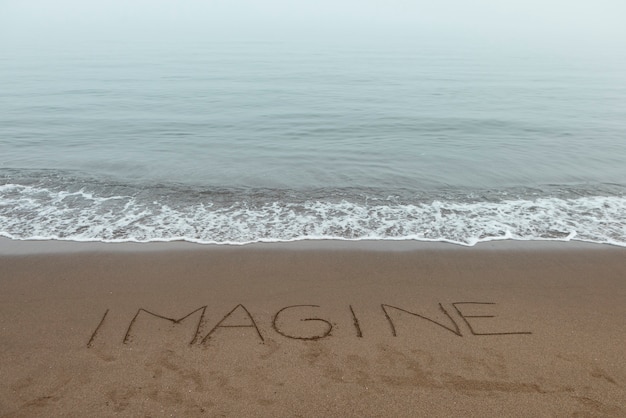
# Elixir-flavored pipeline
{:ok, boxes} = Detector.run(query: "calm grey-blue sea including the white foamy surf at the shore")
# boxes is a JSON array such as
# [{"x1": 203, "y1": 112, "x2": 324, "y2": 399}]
[{"x1": 0, "y1": 40, "x2": 626, "y2": 246}]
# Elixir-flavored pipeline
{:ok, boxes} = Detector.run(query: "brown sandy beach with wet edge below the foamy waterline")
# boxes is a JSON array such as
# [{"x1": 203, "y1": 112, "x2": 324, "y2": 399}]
[{"x1": 0, "y1": 239, "x2": 626, "y2": 417}]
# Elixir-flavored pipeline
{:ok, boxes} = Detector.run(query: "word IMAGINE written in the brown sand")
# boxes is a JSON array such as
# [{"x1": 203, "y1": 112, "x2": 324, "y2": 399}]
[{"x1": 87, "y1": 302, "x2": 532, "y2": 348}]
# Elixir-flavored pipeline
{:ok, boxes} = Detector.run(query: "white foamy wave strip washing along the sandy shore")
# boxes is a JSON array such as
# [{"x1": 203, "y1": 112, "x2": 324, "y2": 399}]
[{"x1": 0, "y1": 184, "x2": 626, "y2": 246}]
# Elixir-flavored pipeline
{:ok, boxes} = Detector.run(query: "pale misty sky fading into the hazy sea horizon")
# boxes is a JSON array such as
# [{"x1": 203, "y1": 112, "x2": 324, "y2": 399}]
[{"x1": 0, "y1": 0, "x2": 626, "y2": 49}]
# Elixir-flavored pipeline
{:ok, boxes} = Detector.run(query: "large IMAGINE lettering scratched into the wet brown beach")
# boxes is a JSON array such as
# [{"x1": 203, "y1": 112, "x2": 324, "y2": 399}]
[{"x1": 87, "y1": 301, "x2": 531, "y2": 348}]
